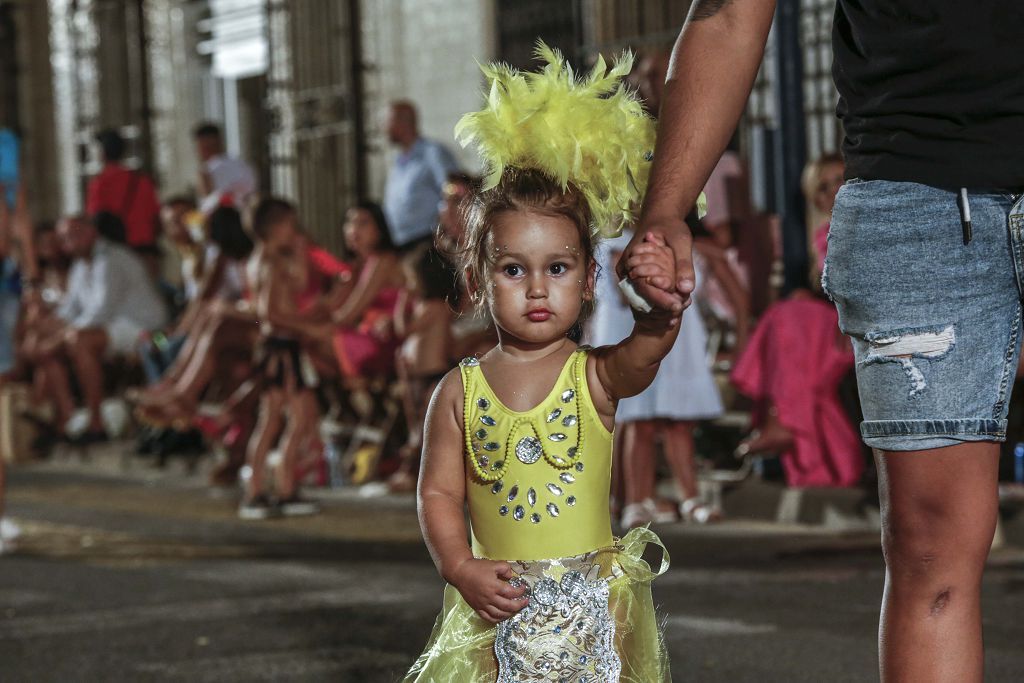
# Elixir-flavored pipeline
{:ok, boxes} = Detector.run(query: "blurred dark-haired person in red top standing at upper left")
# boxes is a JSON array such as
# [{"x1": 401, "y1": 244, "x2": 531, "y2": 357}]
[{"x1": 85, "y1": 130, "x2": 160, "y2": 249}]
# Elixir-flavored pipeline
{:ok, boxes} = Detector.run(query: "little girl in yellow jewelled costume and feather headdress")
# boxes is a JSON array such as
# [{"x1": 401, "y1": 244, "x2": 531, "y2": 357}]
[{"x1": 406, "y1": 45, "x2": 679, "y2": 683}]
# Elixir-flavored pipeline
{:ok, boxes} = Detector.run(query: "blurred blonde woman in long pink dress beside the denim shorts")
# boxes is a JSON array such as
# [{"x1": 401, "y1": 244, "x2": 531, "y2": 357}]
[{"x1": 732, "y1": 156, "x2": 864, "y2": 486}]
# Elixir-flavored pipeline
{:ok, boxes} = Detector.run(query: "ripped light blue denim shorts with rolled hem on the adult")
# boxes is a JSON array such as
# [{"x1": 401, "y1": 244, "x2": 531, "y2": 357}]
[{"x1": 821, "y1": 180, "x2": 1024, "y2": 451}]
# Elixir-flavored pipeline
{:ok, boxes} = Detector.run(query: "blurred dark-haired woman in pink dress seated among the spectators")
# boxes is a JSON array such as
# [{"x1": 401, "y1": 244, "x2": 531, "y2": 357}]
[{"x1": 323, "y1": 202, "x2": 404, "y2": 379}]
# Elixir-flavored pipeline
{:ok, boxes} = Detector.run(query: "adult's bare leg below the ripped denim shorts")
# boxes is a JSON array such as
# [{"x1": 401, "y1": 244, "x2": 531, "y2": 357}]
[{"x1": 876, "y1": 442, "x2": 999, "y2": 683}]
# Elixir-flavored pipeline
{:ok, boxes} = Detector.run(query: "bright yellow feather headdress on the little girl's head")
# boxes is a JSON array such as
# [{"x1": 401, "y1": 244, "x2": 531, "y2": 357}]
[{"x1": 455, "y1": 41, "x2": 654, "y2": 237}]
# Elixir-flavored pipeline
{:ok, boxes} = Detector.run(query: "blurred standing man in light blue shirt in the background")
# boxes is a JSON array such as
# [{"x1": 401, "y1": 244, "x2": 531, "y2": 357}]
[{"x1": 384, "y1": 101, "x2": 457, "y2": 250}]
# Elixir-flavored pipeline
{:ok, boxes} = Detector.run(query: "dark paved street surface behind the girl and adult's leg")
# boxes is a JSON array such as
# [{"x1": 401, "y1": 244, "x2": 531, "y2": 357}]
[{"x1": 0, "y1": 450, "x2": 1024, "y2": 683}]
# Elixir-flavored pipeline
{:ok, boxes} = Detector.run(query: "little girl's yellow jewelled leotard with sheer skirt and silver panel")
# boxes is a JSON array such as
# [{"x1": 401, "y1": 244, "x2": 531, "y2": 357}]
[{"x1": 404, "y1": 347, "x2": 671, "y2": 683}]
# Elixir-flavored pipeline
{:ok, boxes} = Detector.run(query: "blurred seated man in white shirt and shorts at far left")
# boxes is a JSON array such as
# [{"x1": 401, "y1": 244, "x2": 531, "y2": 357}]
[{"x1": 43, "y1": 216, "x2": 167, "y2": 442}]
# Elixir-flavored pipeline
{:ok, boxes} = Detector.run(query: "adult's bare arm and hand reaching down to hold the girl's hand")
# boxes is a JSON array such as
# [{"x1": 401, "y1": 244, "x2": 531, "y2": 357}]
[{"x1": 618, "y1": 0, "x2": 775, "y2": 310}]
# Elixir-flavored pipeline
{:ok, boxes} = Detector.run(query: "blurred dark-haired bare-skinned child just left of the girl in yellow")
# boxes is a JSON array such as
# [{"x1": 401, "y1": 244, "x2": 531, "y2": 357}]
[{"x1": 388, "y1": 247, "x2": 454, "y2": 493}]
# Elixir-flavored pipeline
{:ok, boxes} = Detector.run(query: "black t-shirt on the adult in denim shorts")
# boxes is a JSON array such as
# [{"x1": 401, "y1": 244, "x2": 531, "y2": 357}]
[{"x1": 833, "y1": 0, "x2": 1024, "y2": 189}]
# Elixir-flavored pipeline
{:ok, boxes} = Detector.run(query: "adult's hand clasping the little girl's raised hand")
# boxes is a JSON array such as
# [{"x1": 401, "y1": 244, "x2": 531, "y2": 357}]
[{"x1": 615, "y1": 219, "x2": 695, "y2": 314}]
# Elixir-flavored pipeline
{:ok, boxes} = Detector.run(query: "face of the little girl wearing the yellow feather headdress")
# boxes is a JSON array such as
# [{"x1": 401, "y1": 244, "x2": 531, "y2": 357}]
[{"x1": 482, "y1": 212, "x2": 594, "y2": 344}]
